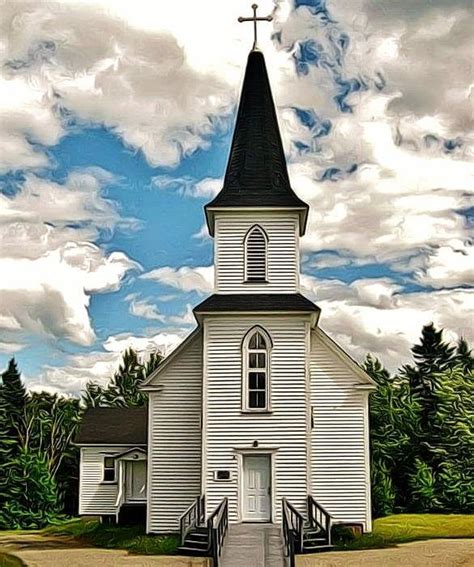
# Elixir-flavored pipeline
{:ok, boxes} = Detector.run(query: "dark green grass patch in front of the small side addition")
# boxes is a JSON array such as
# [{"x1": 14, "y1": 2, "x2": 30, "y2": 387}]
[{"x1": 42, "y1": 519, "x2": 179, "y2": 555}]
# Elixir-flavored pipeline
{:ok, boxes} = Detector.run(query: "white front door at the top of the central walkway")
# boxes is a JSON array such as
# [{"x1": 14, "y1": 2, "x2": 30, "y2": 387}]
[{"x1": 242, "y1": 455, "x2": 271, "y2": 522}]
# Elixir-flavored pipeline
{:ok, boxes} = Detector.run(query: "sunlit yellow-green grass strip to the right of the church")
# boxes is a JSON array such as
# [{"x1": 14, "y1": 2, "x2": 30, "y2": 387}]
[{"x1": 335, "y1": 514, "x2": 474, "y2": 549}]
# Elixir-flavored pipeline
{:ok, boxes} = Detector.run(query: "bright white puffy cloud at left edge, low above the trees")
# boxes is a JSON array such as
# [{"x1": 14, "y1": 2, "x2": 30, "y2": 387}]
[{"x1": 0, "y1": 243, "x2": 137, "y2": 345}]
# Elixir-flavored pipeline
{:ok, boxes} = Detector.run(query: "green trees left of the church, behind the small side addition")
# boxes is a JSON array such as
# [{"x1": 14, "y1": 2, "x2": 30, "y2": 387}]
[{"x1": 0, "y1": 349, "x2": 162, "y2": 529}]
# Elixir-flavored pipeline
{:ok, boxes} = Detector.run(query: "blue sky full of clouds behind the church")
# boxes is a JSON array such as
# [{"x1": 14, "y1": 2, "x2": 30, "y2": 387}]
[{"x1": 0, "y1": 0, "x2": 474, "y2": 394}]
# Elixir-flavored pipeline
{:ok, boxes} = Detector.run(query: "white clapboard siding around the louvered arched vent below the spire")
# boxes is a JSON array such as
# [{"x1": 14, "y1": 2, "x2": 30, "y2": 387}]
[{"x1": 215, "y1": 211, "x2": 299, "y2": 293}]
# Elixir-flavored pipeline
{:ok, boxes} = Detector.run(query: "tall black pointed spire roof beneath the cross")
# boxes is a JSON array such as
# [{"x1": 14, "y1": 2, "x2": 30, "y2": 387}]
[{"x1": 206, "y1": 51, "x2": 308, "y2": 234}]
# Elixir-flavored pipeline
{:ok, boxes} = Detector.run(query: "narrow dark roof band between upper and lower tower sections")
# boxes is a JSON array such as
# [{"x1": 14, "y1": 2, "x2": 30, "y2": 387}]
[{"x1": 194, "y1": 293, "x2": 320, "y2": 314}]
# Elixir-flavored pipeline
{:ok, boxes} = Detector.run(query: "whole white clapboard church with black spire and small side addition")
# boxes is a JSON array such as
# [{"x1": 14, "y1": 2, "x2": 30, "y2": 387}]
[{"x1": 77, "y1": 36, "x2": 374, "y2": 560}]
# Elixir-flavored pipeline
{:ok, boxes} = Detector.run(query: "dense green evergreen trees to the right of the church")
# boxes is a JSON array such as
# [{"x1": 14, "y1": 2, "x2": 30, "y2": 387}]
[{"x1": 364, "y1": 324, "x2": 474, "y2": 516}]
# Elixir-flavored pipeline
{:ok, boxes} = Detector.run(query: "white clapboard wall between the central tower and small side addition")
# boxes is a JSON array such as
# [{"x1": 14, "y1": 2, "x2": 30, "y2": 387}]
[{"x1": 147, "y1": 333, "x2": 202, "y2": 533}]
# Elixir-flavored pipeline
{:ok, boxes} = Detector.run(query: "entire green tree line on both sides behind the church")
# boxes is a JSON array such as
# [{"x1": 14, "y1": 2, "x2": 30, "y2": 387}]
[{"x1": 0, "y1": 324, "x2": 474, "y2": 529}]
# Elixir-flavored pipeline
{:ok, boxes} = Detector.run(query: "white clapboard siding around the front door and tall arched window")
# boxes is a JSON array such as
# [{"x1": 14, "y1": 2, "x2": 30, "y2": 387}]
[{"x1": 204, "y1": 315, "x2": 308, "y2": 523}]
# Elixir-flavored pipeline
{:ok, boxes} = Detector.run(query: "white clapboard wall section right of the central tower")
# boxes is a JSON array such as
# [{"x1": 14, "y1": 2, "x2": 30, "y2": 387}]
[{"x1": 310, "y1": 331, "x2": 371, "y2": 530}]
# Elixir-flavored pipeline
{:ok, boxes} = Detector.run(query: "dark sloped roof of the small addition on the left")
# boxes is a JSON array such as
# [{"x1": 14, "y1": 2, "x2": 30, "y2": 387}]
[{"x1": 74, "y1": 407, "x2": 148, "y2": 445}]
